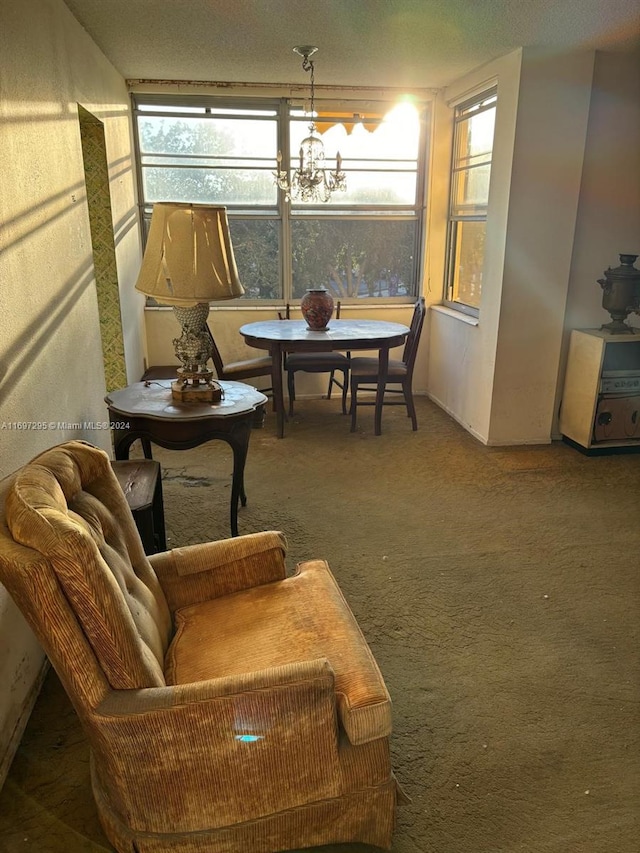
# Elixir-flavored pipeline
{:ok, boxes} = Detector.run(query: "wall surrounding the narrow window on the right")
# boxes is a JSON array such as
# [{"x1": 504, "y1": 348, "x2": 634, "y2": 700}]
[{"x1": 427, "y1": 50, "x2": 522, "y2": 442}]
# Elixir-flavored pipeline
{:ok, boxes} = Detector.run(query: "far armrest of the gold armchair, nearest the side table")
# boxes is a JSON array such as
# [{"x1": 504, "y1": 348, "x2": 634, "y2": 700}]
[{"x1": 149, "y1": 531, "x2": 287, "y2": 612}]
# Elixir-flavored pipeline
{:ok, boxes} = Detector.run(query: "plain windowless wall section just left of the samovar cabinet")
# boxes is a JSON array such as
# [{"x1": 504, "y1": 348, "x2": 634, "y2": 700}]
[{"x1": 490, "y1": 49, "x2": 595, "y2": 444}]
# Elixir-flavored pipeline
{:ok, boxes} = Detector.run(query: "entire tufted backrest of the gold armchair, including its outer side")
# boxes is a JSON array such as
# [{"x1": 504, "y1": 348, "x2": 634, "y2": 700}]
[{"x1": 0, "y1": 441, "x2": 172, "y2": 704}]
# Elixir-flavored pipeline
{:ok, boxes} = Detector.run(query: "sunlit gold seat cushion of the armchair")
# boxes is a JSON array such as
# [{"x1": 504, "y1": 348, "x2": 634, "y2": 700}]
[{"x1": 165, "y1": 560, "x2": 391, "y2": 745}]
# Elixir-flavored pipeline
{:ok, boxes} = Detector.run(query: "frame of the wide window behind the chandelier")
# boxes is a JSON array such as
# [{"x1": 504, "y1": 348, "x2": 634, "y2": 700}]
[{"x1": 131, "y1": 92, "x2": 432, "y2": 307}]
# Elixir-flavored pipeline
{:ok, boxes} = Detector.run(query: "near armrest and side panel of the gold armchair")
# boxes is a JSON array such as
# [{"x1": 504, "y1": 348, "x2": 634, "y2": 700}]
[{"x1": 91, "y1": 658, "x2": 342, "y2": 832}]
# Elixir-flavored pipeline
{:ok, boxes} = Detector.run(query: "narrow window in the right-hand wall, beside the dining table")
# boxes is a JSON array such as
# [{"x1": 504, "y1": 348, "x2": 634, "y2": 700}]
[{"x1": 447, "y1": 89, "x2": 497, "y2": 313}]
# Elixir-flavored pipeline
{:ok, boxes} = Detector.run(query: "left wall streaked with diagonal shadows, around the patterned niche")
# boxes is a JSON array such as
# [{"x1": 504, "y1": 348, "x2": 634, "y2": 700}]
[{"x1": 0, "y1": 0, "x2": 142, "y2": 781}]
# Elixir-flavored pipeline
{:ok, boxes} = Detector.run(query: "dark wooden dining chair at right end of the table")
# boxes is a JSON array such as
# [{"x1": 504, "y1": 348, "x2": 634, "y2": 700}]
[{"x1": 350, "y1": 296, "x2": 426, "y2": 432}]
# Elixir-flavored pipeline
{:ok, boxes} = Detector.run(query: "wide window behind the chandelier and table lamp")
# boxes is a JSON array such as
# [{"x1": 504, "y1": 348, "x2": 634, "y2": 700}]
[{"x1": 134, "y1": 95, "x2": 427, "y2": 301}]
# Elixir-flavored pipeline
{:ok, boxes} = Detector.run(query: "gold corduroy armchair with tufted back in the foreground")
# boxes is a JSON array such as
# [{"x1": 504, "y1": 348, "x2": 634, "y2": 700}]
[{"x1": 0, "y1": 441, "x2": 399, "y2": 853}]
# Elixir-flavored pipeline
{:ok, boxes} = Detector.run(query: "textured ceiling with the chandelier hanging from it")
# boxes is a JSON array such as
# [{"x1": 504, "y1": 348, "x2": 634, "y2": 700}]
[{"x1": 65, "y1": 0, "x2": 640, "y2": 88}]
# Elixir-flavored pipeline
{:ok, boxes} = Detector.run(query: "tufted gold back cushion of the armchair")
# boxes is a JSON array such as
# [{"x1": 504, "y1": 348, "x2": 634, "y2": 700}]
[{"x1": 6, "y1": 441, "x2": 171, "y2": 689}]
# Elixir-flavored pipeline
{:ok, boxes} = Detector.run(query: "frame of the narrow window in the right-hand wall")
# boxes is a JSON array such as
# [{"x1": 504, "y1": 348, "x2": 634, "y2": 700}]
[{"x1": 443, "y1": 83, "x2": 498, "y2": 318}]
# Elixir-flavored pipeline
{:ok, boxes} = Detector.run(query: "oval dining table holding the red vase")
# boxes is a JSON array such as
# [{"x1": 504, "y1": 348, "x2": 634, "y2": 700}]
[{"x1": 240, "y1": 320, "x2": 409, "y2": 438}]
